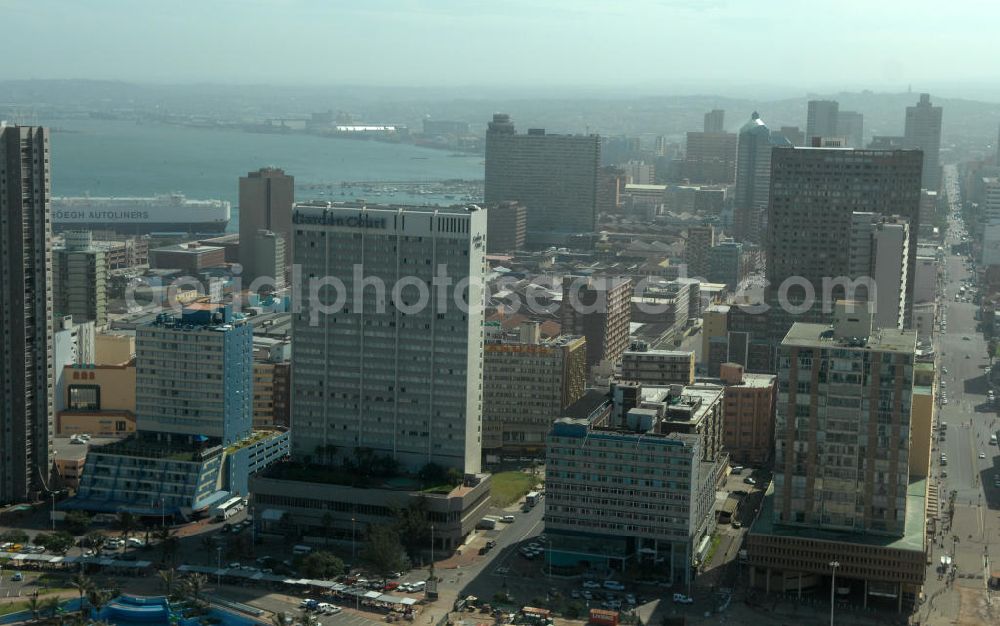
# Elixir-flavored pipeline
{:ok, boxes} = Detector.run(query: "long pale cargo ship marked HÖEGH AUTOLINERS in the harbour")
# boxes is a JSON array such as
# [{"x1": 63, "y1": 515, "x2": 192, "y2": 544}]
[{"x1": 52, "y1": 193, "x2": 231, "y2": 235}]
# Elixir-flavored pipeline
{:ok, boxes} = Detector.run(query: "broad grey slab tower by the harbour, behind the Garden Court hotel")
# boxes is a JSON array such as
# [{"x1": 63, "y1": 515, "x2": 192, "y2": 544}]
[{"x1": 484, "y1": 113, "x2": 601, "y2": 245}]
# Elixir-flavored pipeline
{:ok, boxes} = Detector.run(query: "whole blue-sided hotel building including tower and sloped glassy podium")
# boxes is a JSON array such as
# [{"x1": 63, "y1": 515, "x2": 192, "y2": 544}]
[{"x1": 64, "y1": 303, "x2": 289, "y2": 518}]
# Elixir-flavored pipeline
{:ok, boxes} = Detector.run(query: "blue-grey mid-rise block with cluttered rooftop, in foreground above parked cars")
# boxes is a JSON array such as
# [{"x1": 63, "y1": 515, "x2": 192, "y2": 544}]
[{"x1": 545, "y1": 383, "x2": 722, "y2": 584}]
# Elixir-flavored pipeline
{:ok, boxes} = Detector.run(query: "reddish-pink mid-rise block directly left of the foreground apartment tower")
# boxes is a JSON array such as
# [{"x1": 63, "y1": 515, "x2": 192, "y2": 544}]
[{"x1": 719, "y1": 363, "x2": 778, "y2": 467}]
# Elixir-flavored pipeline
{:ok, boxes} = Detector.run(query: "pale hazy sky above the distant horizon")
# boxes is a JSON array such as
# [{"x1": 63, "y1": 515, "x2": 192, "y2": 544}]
[{"x1": 0, "y1": 0, "x2": 1000, "y2": 93}]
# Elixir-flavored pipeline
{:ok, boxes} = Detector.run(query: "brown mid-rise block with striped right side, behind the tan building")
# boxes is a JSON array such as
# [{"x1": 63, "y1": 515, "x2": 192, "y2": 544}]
[{"x1": 560, "y1": 276, "x2": 632, "y2": 368}]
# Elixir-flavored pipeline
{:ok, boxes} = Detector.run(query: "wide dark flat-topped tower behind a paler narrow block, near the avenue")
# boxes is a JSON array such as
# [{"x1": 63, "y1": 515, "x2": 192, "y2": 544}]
[{"x1": 767, "y1": 148, "x2": 922, "y2": 312}]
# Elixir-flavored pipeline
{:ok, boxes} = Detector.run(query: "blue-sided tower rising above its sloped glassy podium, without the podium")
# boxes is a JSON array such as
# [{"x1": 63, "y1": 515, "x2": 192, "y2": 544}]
[{"x1": 136, "y1": 303, "x2": 253, "y2": 445}]
